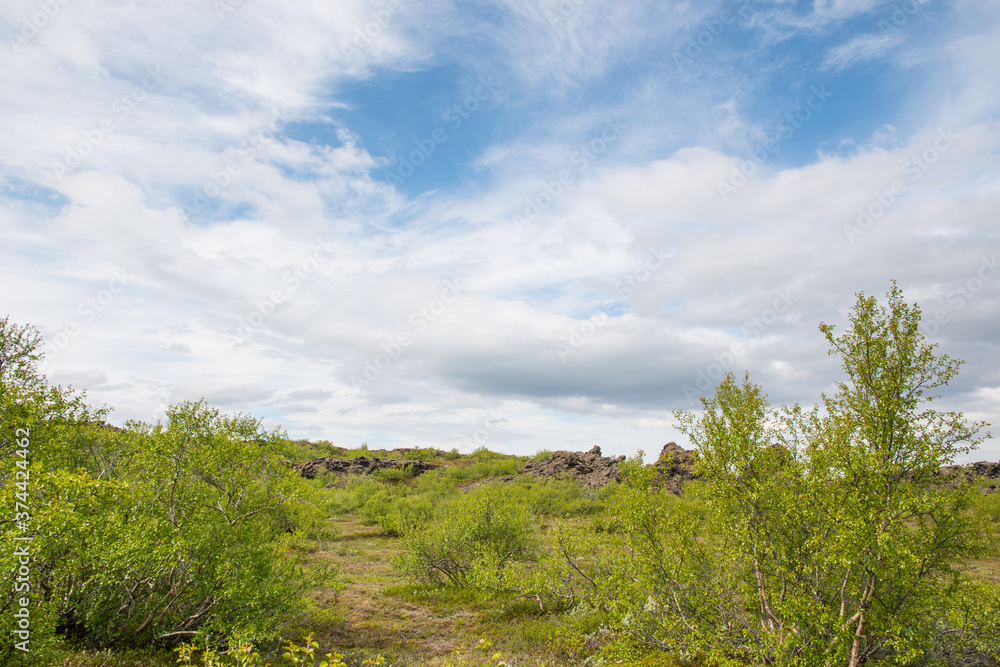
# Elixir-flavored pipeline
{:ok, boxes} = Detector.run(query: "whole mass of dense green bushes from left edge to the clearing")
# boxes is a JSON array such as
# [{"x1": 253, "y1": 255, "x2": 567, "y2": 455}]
[{"x1": 0, "y1": 319, "x2": 311, "y2": 664}]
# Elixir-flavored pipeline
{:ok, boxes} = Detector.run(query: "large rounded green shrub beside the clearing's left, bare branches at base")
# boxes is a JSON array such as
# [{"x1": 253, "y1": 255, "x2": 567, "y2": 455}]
[{"x1": 72, "y1": 402, "x2": 308, "y2": 645}]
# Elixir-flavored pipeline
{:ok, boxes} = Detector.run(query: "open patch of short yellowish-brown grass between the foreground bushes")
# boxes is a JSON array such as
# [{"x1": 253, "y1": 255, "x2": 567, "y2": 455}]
[{"x1": 278, "y1": 516, "x2": 596, "y2": 667}]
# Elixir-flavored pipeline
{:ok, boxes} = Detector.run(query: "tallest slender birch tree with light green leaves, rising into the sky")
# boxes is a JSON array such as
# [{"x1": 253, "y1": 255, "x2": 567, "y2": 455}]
[{"x1": 811, "y1": 283, "x2": 989, "y2": 667}]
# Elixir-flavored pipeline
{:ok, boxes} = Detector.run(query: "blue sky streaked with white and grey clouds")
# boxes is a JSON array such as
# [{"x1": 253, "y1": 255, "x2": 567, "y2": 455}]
[{"x1": 0, "y1": 0, "x2": 1000, "y2": 461}]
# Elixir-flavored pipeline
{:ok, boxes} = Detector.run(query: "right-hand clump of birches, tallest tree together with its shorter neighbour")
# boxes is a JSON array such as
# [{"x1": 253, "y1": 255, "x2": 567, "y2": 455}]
[{"x1": 665, "y1": 285, "x2": 985, "y2": 667}]
